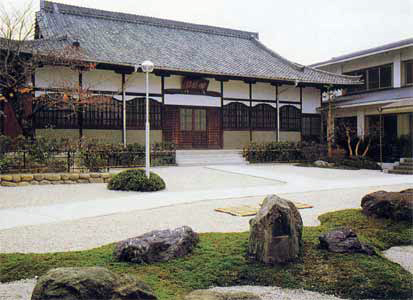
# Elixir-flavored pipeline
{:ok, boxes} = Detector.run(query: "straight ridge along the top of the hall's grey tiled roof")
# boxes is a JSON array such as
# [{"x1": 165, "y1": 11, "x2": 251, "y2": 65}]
[{"x1": 42, "y1": 1, "x2": 258, "y2": 39}]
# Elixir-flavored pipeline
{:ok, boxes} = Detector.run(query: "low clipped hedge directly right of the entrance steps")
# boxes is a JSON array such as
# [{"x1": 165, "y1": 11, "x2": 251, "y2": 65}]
[{"x1": 243, "y1": 142, "x2": 327, "y2": 163}]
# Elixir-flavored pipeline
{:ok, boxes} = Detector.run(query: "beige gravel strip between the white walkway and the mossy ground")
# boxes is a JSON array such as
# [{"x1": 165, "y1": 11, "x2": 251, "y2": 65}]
[{"x1": 0, "y1": 185, "x2": 409, "y2": 253}]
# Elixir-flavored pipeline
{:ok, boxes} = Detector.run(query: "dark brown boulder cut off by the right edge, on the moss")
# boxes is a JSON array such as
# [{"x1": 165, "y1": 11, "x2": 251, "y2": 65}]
[{"x1": 361, "y1": 189, "x2": 413, "y2": 223}]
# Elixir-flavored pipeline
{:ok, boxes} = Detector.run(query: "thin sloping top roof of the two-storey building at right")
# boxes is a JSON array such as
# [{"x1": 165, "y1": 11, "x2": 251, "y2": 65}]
[{"x1": 310, "y1": 38, "x2": 413, "y2": 68}]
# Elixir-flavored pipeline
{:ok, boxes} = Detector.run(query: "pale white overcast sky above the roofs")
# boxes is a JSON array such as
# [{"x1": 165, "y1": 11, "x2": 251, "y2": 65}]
[{"x1": 6, "y1": 0, "x2": 413, "y2": 64}]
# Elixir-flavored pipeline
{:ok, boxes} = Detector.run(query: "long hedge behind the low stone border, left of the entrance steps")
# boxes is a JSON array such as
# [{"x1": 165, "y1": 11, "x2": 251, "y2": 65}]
[{"x1": 0, "y1": 135, "x2": 176, "y2": 173}]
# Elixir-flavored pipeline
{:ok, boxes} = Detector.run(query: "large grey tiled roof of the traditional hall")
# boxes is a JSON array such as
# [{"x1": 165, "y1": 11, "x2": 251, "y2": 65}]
[{"x1": 37, "y1": 2, "x2": 360, "y2": 85}]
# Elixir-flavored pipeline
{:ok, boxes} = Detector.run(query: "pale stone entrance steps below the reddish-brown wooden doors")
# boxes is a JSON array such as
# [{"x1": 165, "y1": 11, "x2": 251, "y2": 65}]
[{"x1": 176, "y1": 150, "x2": 247, "y2": 166}]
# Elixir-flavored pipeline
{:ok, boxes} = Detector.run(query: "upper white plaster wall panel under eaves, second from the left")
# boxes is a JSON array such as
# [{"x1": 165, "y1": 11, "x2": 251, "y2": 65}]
[{"x1": 83, "y1": 70, "x2": 122, "y2": 92}]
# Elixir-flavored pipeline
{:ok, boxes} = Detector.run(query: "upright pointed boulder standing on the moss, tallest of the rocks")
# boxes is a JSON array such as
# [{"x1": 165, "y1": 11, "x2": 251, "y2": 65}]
[{"x1": 248, "y1": 195, "x2": 303, "y2": 264}]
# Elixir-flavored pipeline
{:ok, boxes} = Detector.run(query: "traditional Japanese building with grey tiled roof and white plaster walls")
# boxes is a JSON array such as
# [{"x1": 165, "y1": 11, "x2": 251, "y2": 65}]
[{"x1": 1, "y1": 1, "x2": 360, "y2": 149}]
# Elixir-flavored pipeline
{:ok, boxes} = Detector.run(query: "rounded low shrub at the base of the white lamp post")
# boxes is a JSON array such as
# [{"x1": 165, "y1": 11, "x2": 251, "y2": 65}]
[{"x1": 108, "y1": 169, "x2": 165, "y2": 192}]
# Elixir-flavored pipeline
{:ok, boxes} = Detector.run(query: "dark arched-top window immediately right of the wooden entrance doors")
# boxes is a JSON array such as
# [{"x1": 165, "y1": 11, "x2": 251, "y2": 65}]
[{"x1": 222, "y1": 102, "x2": 249, "y2": 129}]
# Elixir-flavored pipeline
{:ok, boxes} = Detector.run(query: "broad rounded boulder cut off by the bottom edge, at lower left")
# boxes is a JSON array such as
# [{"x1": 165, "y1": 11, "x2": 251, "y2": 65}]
[{"x1": 31, "y1": 267, "x2": 157, "y2": 300}]
